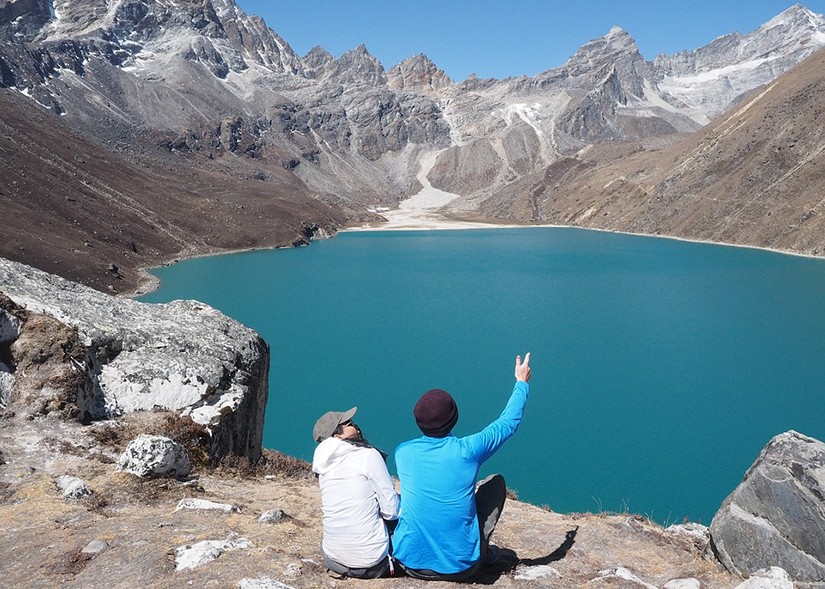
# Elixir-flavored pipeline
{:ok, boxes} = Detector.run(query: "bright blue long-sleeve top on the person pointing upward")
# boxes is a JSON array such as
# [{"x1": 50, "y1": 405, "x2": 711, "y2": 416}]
[{"x1": 392, "y1": 382, "x2": 530, "y2": 574}]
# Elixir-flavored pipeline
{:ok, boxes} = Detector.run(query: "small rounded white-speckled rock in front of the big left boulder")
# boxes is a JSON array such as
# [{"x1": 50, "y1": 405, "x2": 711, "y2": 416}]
[{"x1": 117, "y1": 434, "x2": 192, "y2": 477}]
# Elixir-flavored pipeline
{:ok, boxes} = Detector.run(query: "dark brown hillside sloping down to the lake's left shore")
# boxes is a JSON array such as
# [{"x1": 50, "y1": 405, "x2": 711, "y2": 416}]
[{"x1": 0, "y1": 89, "x2": 345, "y2": 291}]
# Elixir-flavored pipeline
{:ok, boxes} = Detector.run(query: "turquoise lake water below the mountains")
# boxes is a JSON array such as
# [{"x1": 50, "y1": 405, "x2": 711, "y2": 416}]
[{"x1": 142, "y1": 228, "x2": 825, "y2": 524}]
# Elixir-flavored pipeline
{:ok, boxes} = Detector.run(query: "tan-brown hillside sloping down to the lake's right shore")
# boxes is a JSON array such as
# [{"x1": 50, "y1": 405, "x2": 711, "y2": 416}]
[{"x1": 481, "y1": 51, "x2": 825, "y2": 255}]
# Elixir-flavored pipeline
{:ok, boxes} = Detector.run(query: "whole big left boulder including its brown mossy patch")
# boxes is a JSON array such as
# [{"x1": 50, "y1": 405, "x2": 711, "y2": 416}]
[{"x1": 0, "y1": 259, "x2": 269, "y2": 461}]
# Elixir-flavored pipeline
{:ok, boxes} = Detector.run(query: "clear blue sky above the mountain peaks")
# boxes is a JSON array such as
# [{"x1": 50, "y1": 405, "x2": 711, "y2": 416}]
[{"x1": 237, "y1": 0, "x2": 825, "y2": 81}]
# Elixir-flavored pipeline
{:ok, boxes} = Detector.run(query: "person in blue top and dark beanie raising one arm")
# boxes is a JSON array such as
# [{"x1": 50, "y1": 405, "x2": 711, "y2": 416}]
[{"x1": 393, "y1": 353, "x2": 531, "y2": 581}]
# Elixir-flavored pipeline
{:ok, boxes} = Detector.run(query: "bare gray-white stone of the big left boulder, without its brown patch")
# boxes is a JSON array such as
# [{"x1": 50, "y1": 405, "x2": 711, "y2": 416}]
[{"x1": 0, "y1": 259, "x2": 269, "y2": 461}]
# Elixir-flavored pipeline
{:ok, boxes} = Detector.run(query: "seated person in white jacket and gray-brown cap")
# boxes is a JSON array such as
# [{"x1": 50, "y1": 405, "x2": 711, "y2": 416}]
[{"x1": 312, "y1": 407, "x2": 400, "y2": 579}]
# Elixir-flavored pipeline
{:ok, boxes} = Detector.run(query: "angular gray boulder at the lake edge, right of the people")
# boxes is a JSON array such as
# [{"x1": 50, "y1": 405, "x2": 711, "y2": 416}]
[{"x1": 710, "y1": 431, "x2": 825, "y2": 587}]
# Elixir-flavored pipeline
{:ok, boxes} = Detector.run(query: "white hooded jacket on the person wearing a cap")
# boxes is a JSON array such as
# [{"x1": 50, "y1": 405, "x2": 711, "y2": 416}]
[{"x1": 312, "y1": 438, "x2": 399, "y2": 568}]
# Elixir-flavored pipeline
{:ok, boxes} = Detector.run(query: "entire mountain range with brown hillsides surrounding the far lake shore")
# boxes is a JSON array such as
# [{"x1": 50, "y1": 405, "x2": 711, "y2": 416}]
[{"x1": 0, "y1": 0, "x2": 825, "y2": 289}]
